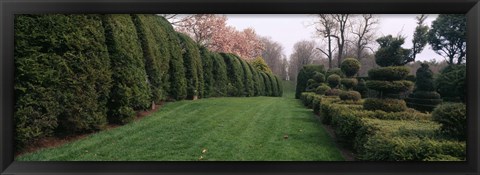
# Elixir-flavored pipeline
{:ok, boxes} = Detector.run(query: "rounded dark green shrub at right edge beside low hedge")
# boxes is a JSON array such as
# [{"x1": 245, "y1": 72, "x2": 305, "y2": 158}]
[{"x1": 432, "y1": 103, "x2": 467, "y2": 140}]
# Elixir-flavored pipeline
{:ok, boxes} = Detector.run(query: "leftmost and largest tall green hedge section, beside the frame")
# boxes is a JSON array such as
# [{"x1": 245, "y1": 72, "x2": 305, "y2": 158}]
[{"x1": 14, "y1": 15, "x2": 111, "y2": 148}]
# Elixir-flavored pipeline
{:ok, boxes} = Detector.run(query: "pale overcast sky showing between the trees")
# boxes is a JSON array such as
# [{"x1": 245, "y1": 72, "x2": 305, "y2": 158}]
[{"x1": 226, "y1": 14, "x2": 443, "y2": 61}]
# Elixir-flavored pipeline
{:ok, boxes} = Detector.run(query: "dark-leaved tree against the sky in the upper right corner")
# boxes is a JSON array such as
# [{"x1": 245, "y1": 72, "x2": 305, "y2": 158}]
[{"x1": 428, "y1": 14, "x2": 467, "y2": 64}]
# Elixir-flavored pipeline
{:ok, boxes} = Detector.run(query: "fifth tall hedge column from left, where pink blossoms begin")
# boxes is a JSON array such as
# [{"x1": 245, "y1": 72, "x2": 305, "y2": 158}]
[{"x1": 177, "y1": 33, "x2": 203, "y2": 98}]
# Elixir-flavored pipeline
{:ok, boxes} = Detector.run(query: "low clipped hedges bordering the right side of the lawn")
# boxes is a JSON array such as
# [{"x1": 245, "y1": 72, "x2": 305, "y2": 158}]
[{"x1": 300, "y1": 92, "x2": 466, "y2": 161}]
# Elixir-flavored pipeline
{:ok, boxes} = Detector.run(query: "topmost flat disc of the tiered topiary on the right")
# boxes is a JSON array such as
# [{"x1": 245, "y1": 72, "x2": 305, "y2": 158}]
[{"x1": 368, "y1": 66, "x2": 410, "y2": 81}]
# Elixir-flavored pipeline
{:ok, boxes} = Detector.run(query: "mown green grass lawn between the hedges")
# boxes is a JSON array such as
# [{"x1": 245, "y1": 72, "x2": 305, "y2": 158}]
[{"x1": 17, "y1": 81, "x2": 344, "y2": 161}]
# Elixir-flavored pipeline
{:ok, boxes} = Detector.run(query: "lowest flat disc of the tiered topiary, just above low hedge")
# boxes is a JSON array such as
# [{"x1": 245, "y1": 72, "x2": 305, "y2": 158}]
[{"x1": 363, "y1": 98, "x2": 407, "y2": 112}]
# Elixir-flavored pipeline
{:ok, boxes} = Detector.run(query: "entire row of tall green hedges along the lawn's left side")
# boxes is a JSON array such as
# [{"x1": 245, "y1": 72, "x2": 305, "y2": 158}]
[{"x1": 14, "y1": 14, "x2": 282, "y2": 149}]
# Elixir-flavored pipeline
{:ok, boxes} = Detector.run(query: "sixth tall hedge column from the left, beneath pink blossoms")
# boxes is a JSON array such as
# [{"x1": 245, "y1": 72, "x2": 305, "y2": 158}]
[{"x1": 199, "y1": 46, "x2": 214, "y2": 98}]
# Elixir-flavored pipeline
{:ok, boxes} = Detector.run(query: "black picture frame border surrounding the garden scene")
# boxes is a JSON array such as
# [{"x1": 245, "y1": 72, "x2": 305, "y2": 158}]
[{"x1": 0, "y1": 0, "x2": 480, "y2": 174}]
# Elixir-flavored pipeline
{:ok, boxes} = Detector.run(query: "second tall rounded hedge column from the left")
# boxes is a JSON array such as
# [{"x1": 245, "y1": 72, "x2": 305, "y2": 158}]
[{"x1": 103, "y1": 15, "x2": 151, "y2": 123}]
